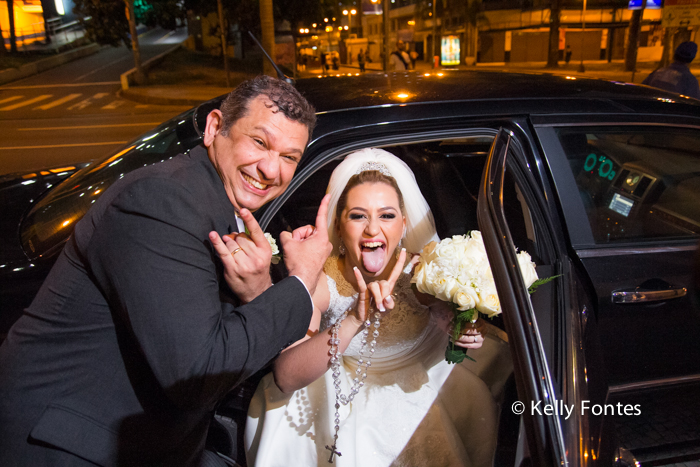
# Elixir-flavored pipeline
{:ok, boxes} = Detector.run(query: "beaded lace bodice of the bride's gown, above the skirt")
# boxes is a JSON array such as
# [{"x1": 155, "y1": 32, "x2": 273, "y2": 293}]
[{"x1": 321, "y1": 256, "x2": 430, "y2": 358}]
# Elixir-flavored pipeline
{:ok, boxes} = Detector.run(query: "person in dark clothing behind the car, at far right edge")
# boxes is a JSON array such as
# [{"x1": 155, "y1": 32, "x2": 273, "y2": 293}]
[{"x1": 642, "y1": 41, "x2": 700, "y2": 99}]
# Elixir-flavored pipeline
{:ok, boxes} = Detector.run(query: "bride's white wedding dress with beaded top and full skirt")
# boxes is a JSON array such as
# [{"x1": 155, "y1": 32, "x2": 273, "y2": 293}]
[{"x1": 245, "y1": 257, "x2": 497, "y2": 467}]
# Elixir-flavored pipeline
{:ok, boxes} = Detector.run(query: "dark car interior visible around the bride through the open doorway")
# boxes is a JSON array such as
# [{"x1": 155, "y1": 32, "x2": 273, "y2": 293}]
[{"x1": 211, "y1": 135, "x2": 555, "y2": 465}]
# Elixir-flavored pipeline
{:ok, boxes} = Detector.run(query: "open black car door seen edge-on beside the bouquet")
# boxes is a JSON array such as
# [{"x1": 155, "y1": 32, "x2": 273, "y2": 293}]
[{"x1": 477, "y1": 128, "x2": 568, "y2": 466}]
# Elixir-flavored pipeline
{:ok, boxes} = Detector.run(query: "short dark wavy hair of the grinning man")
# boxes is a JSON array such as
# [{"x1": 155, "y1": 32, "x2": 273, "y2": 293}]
[{"x1": 219, "y1": 75, "x2": 316, "y2": 141}]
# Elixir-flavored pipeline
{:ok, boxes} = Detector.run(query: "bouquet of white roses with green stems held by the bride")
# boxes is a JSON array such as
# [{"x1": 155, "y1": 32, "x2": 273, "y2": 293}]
[{"x1": 411, "y1": 230, "x2": 553, "y2": 363}]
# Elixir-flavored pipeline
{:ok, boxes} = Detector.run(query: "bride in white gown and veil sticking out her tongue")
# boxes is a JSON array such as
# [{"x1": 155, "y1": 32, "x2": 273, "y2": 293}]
[{"x1": 245, "y1": 149, "x2": 496, "y2": 467}]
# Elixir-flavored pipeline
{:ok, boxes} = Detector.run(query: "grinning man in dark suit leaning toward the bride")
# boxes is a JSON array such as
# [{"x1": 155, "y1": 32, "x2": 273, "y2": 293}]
[{"x1": 0, "y1": 77, "x2": 331, "y2": 466}]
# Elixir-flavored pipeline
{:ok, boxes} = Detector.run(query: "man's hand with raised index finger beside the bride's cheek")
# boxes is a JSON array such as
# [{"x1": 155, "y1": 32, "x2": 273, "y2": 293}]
[{"x1": 280, "y1": 195, "x2": 333, "y2": 295}]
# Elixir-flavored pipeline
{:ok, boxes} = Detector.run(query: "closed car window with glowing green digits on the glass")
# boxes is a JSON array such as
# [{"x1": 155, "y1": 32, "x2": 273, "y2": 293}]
[{"x1": 556, "y1": 126, "x2": 700, "y2": 244}]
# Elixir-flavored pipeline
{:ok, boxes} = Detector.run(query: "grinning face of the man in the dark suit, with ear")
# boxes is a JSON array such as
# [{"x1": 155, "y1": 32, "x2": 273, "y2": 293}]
[{"x1": 204, "y1": 95, "x2": 309, "y2": 211}]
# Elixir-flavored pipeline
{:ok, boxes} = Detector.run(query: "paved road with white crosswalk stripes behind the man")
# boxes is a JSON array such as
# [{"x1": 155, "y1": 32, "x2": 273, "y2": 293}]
[{"x1": 0, "y1": 29, "x2": 188, "y2": 174}]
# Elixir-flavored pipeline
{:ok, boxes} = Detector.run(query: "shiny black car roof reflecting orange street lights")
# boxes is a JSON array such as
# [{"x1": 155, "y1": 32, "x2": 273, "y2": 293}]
[{"x1": 296, "y1": 70, "x2": 700, "y2": 113}]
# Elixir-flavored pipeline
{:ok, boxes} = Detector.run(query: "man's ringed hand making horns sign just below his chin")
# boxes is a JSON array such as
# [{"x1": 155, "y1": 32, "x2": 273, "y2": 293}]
[{"x1": 209, "y1": 209, "x2": 272, "y2": 303}]
